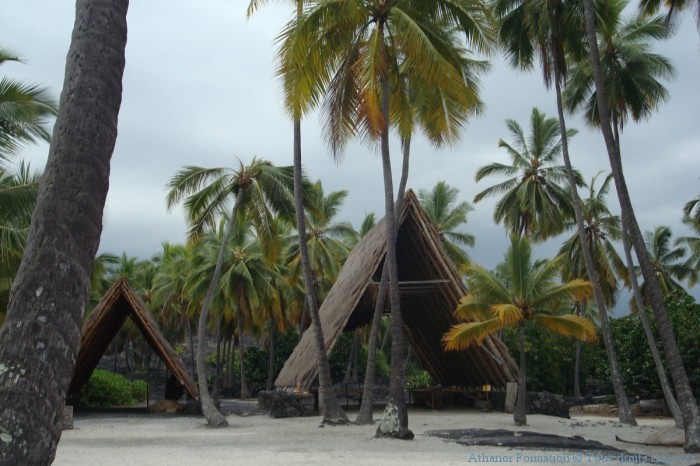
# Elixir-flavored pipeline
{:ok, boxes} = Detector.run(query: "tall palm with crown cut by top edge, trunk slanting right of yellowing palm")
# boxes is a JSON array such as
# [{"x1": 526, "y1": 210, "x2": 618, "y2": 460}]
[{"x1": 496, "y1": 0, "x2": 636, "y2": 425}]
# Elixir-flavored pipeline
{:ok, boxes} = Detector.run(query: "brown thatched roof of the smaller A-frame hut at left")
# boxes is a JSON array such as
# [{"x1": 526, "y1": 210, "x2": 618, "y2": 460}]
[{"x1": 68, "y1": 278, "x2": 197, "y2": 398}]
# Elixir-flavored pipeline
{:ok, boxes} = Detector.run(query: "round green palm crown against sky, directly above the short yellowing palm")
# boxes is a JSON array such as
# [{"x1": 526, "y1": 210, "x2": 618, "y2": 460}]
[{"x1": 474, "y1": 108, "x2": 584, "y2": 241}]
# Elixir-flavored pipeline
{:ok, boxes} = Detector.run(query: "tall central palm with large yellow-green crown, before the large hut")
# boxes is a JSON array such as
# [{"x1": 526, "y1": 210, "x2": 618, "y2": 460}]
[{"x1": 280, "y1": 0, "x2": 488, "y2": 435}]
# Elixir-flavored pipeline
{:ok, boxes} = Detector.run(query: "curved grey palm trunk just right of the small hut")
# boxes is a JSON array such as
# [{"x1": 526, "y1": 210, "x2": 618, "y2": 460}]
[{"x1": 197, "y1": 201, "x2": 238, "y2": 427}]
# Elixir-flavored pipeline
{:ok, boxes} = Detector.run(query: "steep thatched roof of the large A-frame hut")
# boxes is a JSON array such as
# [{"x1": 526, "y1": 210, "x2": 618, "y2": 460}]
[{"x1": 275, "y1": 191, "x2": 518, "y2": 388}]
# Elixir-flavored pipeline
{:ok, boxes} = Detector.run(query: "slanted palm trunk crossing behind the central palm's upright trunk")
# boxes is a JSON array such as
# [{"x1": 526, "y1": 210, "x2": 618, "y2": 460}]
[{"x1": 355, "y1": 138, "x2": 411, "y2": 425}]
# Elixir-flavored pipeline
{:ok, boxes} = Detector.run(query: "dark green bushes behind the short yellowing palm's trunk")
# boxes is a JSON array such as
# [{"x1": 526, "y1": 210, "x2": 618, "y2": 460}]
[{"x1": 503, "y1": 322, "x2": 597, "y2": 395}]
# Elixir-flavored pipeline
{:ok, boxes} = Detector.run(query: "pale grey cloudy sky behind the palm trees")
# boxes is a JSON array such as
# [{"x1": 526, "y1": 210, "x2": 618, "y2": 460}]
[{"x1": 0, "y1": 0, "x2": 700, "y2": 306}]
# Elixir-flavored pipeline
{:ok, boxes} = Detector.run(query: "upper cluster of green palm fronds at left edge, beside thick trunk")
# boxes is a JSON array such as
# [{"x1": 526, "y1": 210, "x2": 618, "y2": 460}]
[{"x1": 0, "y1": 47, "x2": 58, "y2": 168}]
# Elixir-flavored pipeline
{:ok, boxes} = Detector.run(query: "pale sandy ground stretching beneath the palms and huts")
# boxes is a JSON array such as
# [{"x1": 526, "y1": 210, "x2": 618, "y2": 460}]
[{"x1": 54, "y1": 408, "x2": 700, "y2": 466}]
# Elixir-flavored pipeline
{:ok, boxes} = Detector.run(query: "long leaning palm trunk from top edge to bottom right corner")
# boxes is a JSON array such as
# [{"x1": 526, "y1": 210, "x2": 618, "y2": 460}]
[{"x1": 583, "y1": 0, "x2": 700, "y2": 452}]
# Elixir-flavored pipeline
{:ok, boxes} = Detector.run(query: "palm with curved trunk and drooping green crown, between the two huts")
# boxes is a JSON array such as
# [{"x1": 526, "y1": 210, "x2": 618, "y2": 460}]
[{"x1": 166, "y1": 158, "x2": 294, "y2": 427}]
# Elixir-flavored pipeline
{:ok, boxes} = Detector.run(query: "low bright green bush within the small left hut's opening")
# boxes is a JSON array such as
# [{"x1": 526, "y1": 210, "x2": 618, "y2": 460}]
[{"x1": 80, "y1": 369, "x2": 148, "y2": 408}]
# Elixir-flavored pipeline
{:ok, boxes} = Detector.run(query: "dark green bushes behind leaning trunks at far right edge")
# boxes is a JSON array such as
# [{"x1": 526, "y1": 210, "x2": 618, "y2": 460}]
[{"x1": 593, "y1": 291, "x2": 700, "y2": 398}]
